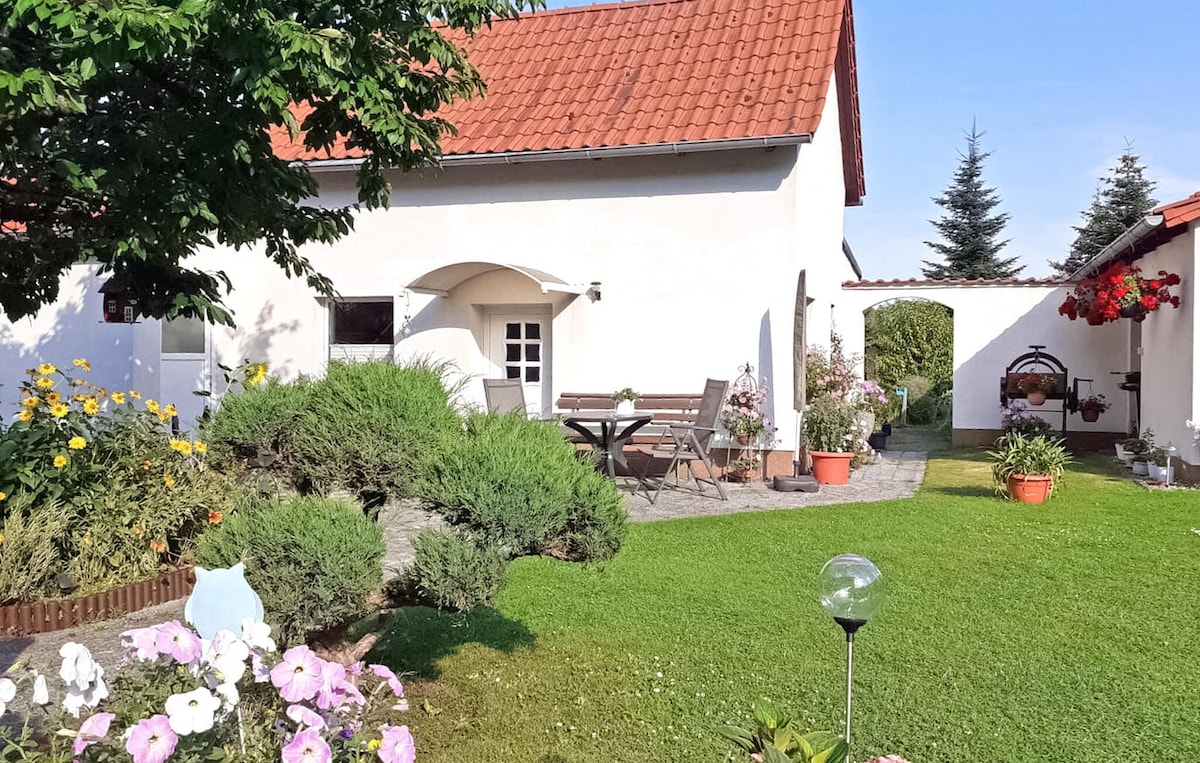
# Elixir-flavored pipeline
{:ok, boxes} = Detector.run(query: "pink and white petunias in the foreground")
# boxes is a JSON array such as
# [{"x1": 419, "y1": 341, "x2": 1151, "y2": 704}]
[{"x1": 0, "y1": 619, "x2": 416, "y2": 763}]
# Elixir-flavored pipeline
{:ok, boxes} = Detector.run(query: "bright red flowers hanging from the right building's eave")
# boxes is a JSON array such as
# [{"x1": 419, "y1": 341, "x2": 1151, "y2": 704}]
[{"x1": 1058, "y1": 262, "x2": 1180, "y2": 326}]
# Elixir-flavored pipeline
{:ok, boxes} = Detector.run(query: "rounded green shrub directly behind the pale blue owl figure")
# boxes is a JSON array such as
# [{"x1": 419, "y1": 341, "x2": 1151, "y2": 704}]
[{"x1": 196, "y1": 497, "x2": 384, "y2": 644}]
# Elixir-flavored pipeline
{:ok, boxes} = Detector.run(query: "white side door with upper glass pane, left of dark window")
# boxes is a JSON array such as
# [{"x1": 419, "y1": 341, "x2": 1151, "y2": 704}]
[{"x1": 158, "y1": 318, "x2": 212, "y2": 432}]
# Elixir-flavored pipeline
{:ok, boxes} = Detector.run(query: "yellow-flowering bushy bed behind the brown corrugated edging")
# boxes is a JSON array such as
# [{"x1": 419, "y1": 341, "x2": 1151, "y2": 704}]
[{"x1": 0, "y1": 358, "x2": 247, "y2": 605}]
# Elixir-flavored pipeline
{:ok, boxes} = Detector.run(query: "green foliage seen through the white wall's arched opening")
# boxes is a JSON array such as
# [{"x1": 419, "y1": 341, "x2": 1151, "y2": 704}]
[{"x1": 863, "y1": 301, "x2": 954, "y2": 392}]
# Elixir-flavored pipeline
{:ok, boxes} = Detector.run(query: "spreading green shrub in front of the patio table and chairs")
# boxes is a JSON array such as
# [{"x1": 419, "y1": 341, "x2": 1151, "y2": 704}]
[{"x1": 419, "y1": 414, "x2": 626, "y2": 560}]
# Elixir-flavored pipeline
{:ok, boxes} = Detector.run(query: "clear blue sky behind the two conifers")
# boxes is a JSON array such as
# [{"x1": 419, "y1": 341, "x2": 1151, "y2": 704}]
[{"x1": 540, "y1": 0, "x2": 1200, "y2": 278}]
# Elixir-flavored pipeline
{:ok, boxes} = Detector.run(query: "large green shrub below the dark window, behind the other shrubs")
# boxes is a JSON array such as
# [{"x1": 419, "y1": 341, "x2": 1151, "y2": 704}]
[{"x1": 286, "y1": 360, "x2": 461, "y2": 498}]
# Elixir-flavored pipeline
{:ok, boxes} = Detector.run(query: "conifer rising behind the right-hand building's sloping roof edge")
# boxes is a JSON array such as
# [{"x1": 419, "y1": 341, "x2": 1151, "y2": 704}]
[{"x1": 1050, "y1": 146, "x2": 1158, "y2": 277}]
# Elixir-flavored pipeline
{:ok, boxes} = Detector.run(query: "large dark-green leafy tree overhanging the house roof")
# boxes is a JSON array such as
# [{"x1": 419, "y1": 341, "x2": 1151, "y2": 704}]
[{"x1": 0, "y1": 0, "x2": 540, "y2": 323}]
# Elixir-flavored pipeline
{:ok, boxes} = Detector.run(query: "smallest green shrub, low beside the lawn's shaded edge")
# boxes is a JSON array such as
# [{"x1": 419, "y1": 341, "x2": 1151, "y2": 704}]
[{"x1": 406, "y1": 529, "x2": 509, "y2": 612}]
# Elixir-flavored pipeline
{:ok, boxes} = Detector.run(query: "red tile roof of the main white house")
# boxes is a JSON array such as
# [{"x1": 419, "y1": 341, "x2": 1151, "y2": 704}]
[{"x1": 272, "y1": 0, "x2": 862, "y2": 203}]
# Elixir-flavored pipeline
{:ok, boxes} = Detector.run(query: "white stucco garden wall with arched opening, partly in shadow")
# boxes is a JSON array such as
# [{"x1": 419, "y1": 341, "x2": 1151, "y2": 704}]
[{"x1": 839, "y1": 284, "x2": 1132, "y2": 432}]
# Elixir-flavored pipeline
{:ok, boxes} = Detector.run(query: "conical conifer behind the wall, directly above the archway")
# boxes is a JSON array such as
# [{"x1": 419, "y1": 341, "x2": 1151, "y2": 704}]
[{"x1": 922, "y1": 126, "x2": 1025, "y2": 280}]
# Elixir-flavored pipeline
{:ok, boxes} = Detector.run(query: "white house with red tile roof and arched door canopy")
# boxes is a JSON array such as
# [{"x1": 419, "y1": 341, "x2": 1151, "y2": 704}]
[{"x1": 0, "y1": 0, "x2": 864, "y2": 471}]
